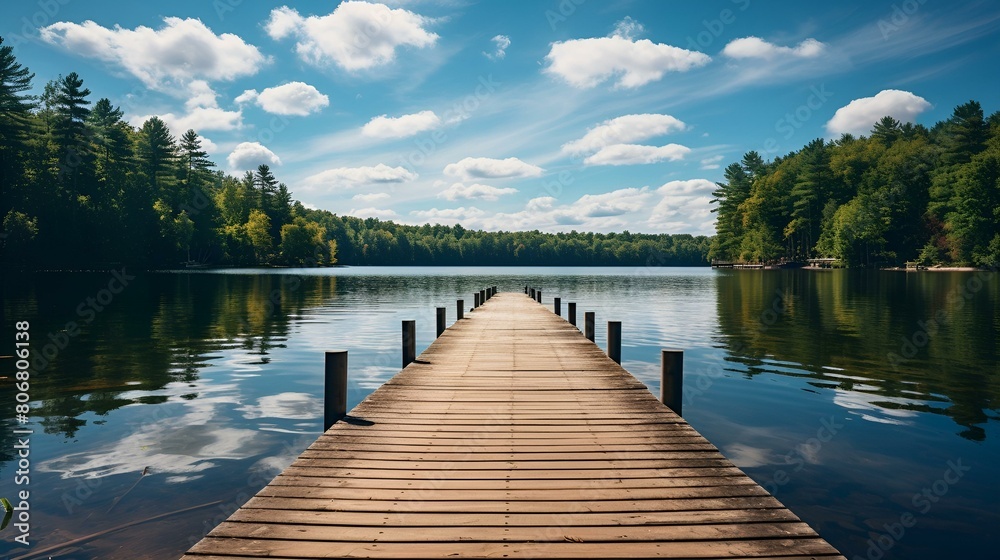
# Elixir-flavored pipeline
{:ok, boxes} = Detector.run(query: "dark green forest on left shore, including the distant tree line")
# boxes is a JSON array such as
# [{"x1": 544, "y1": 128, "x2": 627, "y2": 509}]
[{"x1": 0, "y1": 38, "x2": 710, "y2": 270}]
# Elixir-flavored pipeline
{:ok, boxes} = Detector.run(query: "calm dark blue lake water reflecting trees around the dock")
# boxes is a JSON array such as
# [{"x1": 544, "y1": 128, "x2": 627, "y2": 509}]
[{"x1": 0, "y1": 268, "x2": 1000, "y2": 559}]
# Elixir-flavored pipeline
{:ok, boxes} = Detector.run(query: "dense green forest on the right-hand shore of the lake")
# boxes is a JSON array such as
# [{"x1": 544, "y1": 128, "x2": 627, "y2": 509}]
[{"x1": 710, "y1": 101, "x2": 1000, "y2": 267}]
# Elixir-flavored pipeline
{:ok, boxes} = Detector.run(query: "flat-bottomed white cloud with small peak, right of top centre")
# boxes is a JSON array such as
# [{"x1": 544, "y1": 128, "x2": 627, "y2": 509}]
[{"x1": 544, "y1": 19, "x2": 712, "y2": 88}]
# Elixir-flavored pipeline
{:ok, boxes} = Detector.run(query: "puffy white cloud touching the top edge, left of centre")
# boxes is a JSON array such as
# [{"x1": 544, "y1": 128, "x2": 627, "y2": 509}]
[{"x1": 265, "y1": 1, "x2": 438, "y2": 71}]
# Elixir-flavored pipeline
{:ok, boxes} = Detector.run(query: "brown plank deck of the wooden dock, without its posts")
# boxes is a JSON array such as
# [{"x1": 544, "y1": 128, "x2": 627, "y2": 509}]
[{"x1": 182, "y1": 293, "x2": 843, "y2": 560}]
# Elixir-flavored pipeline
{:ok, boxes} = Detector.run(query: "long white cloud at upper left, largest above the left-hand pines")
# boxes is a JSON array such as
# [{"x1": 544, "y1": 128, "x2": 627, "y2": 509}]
[{"x1": 40, "y1": 17, "x2": 268, "y2": 91}]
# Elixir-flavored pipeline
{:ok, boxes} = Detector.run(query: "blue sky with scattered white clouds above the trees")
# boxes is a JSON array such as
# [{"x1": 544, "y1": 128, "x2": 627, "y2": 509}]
[{"x1": 0, "y1": 0, "x2": 1000, "y2": 235}]
